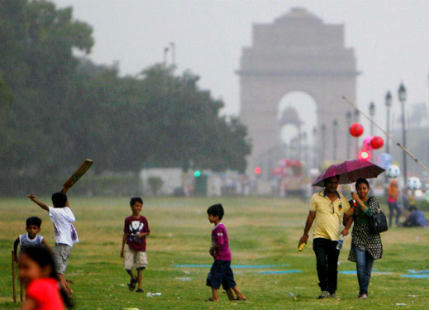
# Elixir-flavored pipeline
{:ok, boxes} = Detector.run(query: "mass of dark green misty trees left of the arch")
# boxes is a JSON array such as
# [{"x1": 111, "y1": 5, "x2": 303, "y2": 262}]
[{"x1": 0, "y1": 0, "x2": 250, "y2": 194}]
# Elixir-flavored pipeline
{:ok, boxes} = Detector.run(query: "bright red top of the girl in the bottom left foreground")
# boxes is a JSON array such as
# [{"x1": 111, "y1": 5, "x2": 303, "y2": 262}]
[{"x1": 27, "y1": 278, "x2": 65, "y2": 310}]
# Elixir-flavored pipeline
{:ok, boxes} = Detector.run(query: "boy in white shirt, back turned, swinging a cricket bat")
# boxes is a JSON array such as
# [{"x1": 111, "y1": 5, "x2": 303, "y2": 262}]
[{"x1": 28, "y1": 190, "x2": 79, "y2": 295}]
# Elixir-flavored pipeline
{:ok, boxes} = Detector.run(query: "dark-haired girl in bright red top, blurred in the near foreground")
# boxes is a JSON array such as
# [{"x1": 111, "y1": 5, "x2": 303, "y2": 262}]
[{"x1": 18, "y1": 247, "x2": 73, "y2": 310}]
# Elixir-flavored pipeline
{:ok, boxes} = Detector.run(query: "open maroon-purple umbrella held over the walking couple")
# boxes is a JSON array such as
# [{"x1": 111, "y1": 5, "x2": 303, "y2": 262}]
[{"x1": 312, "y1": 159, "x2": 384, "y2": 187}]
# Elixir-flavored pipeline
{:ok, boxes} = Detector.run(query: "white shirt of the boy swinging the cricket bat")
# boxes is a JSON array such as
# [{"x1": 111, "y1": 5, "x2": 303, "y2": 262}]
[{"x1": 49, "y1": 207, "x2": 79, "y2": 246}]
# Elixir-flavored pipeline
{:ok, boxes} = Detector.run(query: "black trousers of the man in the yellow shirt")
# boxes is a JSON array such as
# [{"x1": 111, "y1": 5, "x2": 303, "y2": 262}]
[{"x1": 313, "y1": 238, "x2": 340, "y2": 294}]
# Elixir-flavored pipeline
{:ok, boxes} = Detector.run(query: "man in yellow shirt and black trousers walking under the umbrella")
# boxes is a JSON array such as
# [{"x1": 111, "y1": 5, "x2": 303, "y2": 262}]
[{"x1": 299, "y1": 177, "x2": 351, "y2": 299}]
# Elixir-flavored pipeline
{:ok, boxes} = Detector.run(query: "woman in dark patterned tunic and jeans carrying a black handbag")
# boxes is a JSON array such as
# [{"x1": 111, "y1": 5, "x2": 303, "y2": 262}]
[{"x1": 349, "y1": 179, "x2": 383, "y2": 299}]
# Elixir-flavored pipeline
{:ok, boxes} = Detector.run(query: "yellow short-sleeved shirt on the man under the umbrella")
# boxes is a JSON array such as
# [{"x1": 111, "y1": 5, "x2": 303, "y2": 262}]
[{"x1": 310, "y1": 191, "x2": 350, "y2": 241}]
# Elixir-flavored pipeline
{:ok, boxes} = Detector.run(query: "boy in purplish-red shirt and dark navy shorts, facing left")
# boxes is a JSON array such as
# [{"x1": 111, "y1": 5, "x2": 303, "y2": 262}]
[{"x1": 206, "y1": 204, "x2": 246, "y2": 301}]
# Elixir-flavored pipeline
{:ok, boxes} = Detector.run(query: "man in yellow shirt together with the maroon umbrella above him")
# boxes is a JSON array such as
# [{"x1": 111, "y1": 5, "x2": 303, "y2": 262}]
[{"x1": 299, "y1": 160, "x2": 384, "y2": 299}]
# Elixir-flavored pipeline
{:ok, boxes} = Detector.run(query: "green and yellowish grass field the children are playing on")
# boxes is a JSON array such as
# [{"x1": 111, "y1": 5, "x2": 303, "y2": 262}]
[{"x1": 0, "y1": 196, "x2": 429, "y2": 309}]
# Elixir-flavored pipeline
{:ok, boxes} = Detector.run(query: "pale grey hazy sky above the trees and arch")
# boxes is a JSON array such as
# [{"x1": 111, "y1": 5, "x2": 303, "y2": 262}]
[{"x1": 54, "y1": 0, "x2": 429, "y2": 132}]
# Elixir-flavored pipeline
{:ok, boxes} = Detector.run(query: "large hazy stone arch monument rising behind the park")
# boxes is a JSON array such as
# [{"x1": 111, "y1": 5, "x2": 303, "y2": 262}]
[{"x1": 237, "y1": 8, "x2": 359, "y2": 176}]
